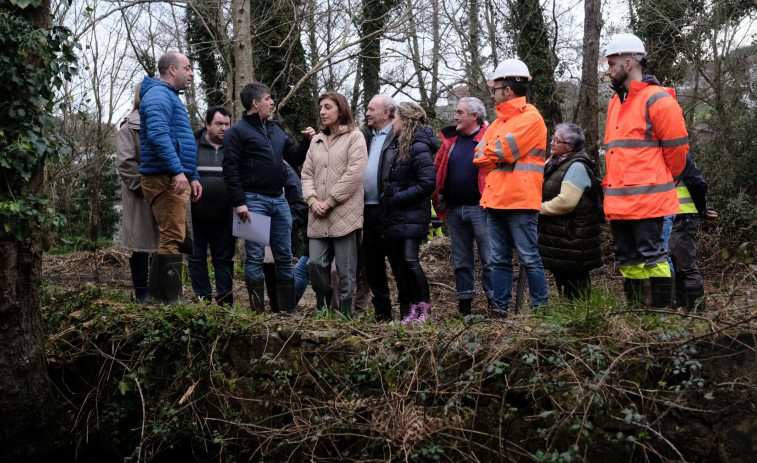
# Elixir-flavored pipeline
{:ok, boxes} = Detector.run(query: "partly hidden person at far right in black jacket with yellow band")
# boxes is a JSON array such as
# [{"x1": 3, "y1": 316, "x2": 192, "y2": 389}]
[{"x1": 668, "y1": 153, "x2": 718, "y2": 311}]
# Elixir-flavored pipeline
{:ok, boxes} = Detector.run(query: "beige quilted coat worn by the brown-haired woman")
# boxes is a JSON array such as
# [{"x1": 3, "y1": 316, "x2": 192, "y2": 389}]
[{"x1": 302, "y1": 125, "x2": 368, "y2": 238}]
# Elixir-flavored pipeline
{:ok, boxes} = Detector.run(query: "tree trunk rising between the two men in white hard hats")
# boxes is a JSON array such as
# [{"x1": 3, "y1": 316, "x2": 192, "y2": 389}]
[{"x1": 578, "y1": 0, "x2": 602, "y2": 169}]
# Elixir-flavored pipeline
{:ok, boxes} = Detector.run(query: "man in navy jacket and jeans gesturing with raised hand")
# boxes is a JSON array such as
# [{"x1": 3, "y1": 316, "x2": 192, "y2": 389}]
[{"x1": 223, "y1": 84, "x2": 315, "y2": 314}]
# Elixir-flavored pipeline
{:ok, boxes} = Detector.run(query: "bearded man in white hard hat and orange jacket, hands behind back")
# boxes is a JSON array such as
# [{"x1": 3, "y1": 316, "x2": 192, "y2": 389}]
[{"x1": 600, "y1": 34, "x2": 689, "y2": 307}]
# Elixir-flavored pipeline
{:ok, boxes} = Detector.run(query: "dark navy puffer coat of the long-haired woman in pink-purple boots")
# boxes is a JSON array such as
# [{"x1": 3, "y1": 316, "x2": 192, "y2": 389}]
[{"x1": 380, "y1": 127, "x2": 438, "y2": 239}]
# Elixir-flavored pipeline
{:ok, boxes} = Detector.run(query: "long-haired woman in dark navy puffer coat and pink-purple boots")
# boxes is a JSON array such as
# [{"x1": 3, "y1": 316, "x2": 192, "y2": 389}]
[{"x1": 380, "y1": 103, "x2": 438, "y2": 324}]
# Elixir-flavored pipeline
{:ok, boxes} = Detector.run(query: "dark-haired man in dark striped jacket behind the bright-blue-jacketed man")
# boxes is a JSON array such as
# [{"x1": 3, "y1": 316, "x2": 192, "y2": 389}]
[{"x1": 187, "y1": 106, "x2": 236, "y2": 305}]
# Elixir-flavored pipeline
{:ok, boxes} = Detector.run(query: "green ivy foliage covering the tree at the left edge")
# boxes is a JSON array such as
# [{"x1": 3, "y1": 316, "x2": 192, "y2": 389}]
[{"x1": 0, "y1": 7, "x2": 77, "y2": 241}]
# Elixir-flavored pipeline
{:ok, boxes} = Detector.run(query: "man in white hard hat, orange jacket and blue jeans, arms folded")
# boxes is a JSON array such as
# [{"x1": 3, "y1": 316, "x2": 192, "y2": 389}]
[{"x1": 473, "y1": 59, "x2": 547, "y2": 316}]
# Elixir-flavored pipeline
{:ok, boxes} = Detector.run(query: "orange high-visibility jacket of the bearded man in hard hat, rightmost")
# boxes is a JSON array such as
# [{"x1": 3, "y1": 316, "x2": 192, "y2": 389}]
[{"x1": 602, "y1": 81, "x2": 689, "y2": 220}]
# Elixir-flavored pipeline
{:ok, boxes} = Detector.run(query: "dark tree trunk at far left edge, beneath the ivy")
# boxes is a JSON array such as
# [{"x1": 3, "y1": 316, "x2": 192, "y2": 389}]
[{"x1": 0, "y1": 6, "x2": 57, "y2": 462}]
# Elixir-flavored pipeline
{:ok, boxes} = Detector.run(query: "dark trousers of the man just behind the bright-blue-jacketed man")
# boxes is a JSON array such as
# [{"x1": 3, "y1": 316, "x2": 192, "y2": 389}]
[{"x1": 187, "y1": 217, "x2": 236, "y2": 296}]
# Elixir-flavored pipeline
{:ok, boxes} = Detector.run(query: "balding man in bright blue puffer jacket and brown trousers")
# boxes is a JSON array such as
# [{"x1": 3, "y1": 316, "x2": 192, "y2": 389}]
[{"x1": 139, "y1": 52, "x2": 202, "y2": 303}]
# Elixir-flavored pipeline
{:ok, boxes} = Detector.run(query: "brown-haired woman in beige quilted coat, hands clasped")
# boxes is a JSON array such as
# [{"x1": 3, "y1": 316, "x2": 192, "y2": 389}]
[{"x1": 302, "y1": 92, "x2": 368, "y2": 317}]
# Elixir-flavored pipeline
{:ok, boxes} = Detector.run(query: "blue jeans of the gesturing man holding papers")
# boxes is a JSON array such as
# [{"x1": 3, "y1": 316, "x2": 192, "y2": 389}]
[{"x1": 244, "y1": 193, "x2": 294, "y2": 280}]
